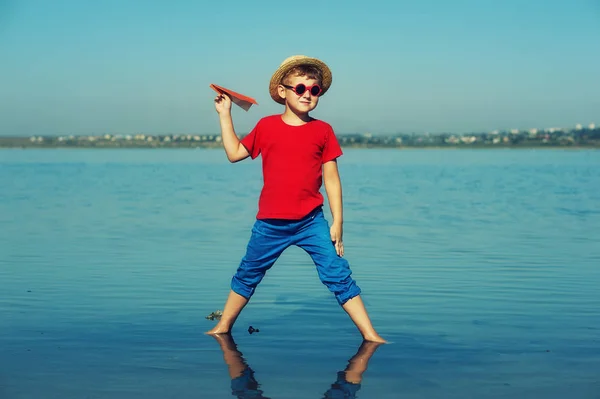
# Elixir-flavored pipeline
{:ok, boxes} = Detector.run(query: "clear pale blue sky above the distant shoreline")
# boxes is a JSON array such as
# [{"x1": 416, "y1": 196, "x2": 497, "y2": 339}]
[{"x1": 0, "y1": 0, "x2": 600, "y2": 136}]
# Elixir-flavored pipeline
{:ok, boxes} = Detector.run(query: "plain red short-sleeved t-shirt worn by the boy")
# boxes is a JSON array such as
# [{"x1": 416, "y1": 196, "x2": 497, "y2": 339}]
[{"x1": 241, "y1": 115, "x2": 342, "y2": 220}]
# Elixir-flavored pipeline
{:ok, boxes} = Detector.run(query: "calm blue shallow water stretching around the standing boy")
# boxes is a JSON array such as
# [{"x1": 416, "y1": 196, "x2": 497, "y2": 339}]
[{"x1": 0, "y1": 149, "x2": 600, "y2": 399}]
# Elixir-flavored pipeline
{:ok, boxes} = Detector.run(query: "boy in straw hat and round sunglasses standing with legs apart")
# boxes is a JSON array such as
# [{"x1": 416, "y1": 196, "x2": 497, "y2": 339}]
[{"x1": 207, "y1": 56, "x2": 385, "y2": 342}]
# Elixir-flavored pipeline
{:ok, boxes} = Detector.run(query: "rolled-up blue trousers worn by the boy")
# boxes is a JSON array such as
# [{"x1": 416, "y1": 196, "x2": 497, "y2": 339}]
[{"x1": 231, "y1": 207, "x2": 360, "y2": 305}]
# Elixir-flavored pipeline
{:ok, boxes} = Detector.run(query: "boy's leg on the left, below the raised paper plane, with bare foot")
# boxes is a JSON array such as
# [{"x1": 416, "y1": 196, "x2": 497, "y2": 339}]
[{"x1": 206, "y1": 220, "x2": 290, "y2": 334}]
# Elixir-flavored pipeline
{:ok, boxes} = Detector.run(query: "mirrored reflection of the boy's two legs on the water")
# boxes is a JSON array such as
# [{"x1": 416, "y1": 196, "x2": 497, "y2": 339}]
[{"x1": 213, "y1": 334, "x2": 381, "y2": 399}]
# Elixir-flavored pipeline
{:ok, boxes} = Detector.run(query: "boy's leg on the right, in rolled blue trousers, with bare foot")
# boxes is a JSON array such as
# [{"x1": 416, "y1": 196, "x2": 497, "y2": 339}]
[{"x1": 295, "y1": 212, "x2": 385, "y2": 342}]
